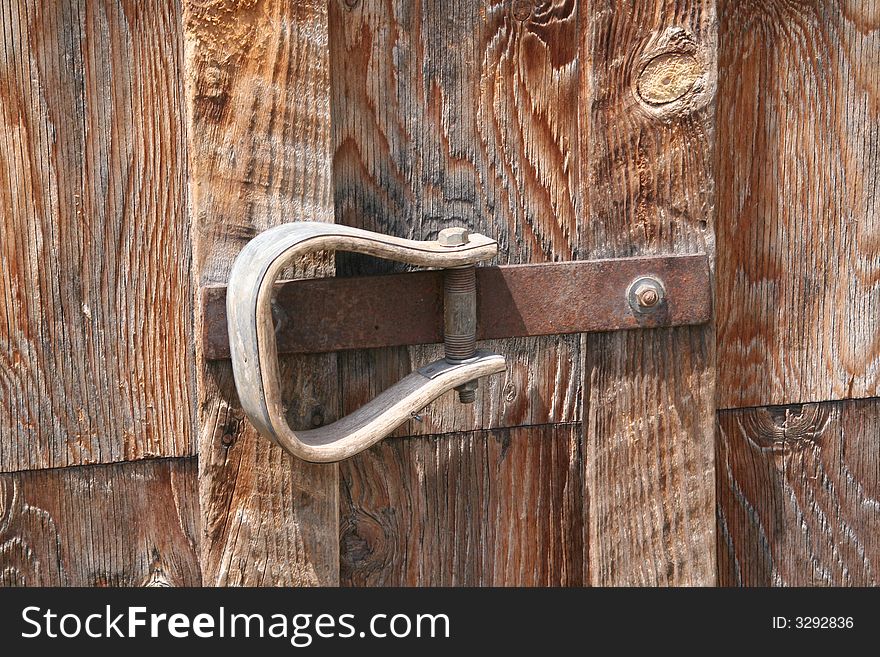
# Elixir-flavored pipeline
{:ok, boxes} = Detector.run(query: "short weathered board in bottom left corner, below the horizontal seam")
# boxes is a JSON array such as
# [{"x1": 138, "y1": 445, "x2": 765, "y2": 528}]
[{"x1": 0, "y1": 458, "x2": 201, "y2": 586}]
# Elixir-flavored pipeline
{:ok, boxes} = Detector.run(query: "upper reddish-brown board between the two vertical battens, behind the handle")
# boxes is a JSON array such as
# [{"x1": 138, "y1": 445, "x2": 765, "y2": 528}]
[{"x1": 330, "y1": 0, "x2": 581, "y2": 435}]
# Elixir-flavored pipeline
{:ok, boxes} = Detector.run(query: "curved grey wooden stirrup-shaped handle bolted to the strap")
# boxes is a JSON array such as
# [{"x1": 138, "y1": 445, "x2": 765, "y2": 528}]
[{"x1": 226, "y1": 222, "x2": 506, "y2": 463}]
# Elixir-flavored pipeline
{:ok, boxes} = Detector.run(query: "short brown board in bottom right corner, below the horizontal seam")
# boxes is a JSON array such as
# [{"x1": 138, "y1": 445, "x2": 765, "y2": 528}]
[{"x1": 717, "y1": 399, "x2": 880, "y2": 586}]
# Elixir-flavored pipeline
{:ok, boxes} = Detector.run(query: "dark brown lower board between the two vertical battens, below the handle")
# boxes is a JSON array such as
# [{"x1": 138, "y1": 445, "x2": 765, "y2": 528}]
[{"x1": 340, "y1": 424, "x2": 587, "y2": 586}]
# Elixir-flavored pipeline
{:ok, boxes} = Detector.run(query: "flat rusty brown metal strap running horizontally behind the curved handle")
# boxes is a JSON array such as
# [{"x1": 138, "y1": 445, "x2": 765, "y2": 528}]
[{"x1": 201, "y1": 255, "x2": 712, "y2": 360}]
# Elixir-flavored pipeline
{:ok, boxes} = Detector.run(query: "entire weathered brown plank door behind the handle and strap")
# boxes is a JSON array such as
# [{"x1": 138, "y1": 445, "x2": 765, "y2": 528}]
[{"x1": 0, "y1": 0, "x2": 880, "y2": 585}]
